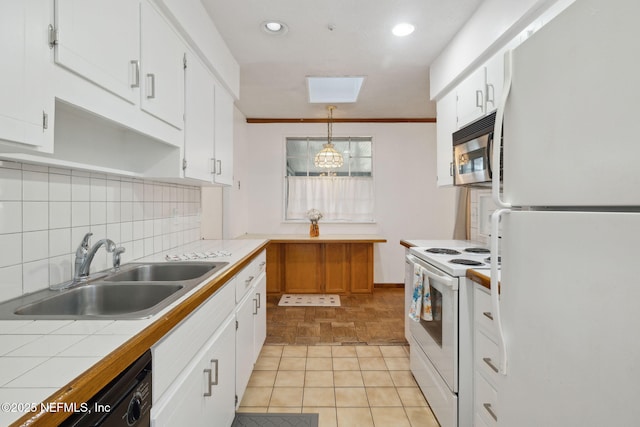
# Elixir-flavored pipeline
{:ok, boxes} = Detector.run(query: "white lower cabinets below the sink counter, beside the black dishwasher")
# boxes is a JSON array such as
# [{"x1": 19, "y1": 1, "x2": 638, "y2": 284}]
[{"x1": 151, "y1": 251, "x2": 267, "y2": 427}]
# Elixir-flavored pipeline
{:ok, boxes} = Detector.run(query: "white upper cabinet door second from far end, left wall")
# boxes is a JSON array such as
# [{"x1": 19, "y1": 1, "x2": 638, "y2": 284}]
[{"x1": 184, "y1": 53, "x2": 215, "y2": 182}]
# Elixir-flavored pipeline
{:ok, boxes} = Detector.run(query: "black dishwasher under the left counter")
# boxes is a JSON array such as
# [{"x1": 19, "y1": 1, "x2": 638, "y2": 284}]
[{"x1": 61, "y1": 351, "x2": 151, "y2": 427}]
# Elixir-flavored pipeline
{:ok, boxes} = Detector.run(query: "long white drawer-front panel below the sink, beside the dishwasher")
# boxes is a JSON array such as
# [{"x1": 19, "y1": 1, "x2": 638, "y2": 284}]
[{"x1": 151, "y1": 280, "x2": 235, "y2": 404}]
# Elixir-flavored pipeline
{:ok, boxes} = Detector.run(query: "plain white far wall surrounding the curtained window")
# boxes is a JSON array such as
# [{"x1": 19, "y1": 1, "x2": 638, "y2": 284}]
[{"x1": 242, "y1": 123, "x2": 456, "y2": 283}]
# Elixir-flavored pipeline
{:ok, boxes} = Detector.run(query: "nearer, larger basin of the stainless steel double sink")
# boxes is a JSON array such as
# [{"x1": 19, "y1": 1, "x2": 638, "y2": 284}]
[{"x1": 15, "y1": 282, "x2": 184, "y2": 317}]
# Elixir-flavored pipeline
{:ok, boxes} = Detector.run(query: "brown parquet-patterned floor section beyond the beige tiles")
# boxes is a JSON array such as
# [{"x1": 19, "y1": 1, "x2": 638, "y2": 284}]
[{"x1": 266, "y1": 288, "x2": 407, "y2": 345}]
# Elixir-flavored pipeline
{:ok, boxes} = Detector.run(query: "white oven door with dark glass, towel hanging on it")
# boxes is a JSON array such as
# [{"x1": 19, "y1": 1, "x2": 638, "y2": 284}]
[{"x1": 407, "y1": 255, "x2": 458, "y2": 392}]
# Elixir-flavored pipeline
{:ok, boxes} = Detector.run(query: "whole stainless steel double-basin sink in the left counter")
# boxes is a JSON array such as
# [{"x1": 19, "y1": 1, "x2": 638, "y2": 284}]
[{"x1": 0, "y1": 262, "x2": 228, "y2": 320}]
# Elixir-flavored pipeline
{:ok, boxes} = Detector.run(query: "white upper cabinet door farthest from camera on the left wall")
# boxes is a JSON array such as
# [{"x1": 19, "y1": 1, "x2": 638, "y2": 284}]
[{"x1": 214, "y1": 84, "x2": 233, "y2": 185}]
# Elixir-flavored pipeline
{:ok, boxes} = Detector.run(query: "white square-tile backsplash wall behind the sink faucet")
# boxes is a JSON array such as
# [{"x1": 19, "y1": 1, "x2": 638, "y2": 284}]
[{"x1": 0, "y1": 160, "x2": 200, "y2": 301}]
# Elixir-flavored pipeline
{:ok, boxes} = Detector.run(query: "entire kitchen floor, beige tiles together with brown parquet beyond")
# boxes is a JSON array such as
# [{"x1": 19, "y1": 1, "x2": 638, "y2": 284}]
[{"x1": 238, "y1": 289, "x2": 438, "y2": 427}]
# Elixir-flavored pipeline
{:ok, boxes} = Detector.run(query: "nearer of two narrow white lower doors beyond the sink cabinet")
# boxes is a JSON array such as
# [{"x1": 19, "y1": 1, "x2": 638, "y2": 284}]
[{"x1": 235, "y1": 292, "x2": 257, "y2": 403}]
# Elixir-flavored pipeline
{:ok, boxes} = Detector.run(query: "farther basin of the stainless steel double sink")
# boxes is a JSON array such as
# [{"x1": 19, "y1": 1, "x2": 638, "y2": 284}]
[{"x1": 104, "y1": 262, "x2": 222, "y2": 282}]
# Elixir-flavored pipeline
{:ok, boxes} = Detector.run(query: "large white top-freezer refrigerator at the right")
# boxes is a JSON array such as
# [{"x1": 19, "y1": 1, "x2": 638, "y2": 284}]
[{"x1": 491, "y1": 0, "x2": 640, "y2": 427}]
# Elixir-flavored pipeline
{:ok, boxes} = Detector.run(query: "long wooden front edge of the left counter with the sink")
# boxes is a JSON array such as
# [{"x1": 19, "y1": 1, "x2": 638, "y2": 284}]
[{"x1": 10, "y1": 241, "x2": 269, "y2": 427}]
